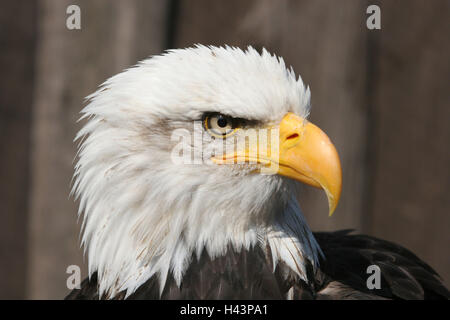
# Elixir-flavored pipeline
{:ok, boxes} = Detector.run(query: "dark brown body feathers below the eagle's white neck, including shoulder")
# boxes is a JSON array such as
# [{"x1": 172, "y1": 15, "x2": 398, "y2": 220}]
[{"x1": 66, "y1": 231, "x2": 450, "y2": 299}]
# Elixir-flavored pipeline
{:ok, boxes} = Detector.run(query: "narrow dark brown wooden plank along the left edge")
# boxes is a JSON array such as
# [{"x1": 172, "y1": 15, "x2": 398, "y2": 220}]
[{"x1": 0, "y1": 1, "x2": 36, "y2": 299}]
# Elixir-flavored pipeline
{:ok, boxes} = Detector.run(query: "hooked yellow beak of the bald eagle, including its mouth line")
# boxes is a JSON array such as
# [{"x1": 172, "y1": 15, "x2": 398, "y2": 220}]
[{"x1": 212, "y1": 113, "x2": 342, "y2": 216}]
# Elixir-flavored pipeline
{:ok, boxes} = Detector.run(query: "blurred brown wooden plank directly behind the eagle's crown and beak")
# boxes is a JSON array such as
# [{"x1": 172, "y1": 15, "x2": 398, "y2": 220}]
[{"x1": 175, "y1": 0, "x2": 368, "y2": 230}]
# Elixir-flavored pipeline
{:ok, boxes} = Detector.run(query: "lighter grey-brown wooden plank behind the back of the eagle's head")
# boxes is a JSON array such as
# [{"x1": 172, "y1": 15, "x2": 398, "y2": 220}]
[{"x1": 28, "y1": 0, "x2": 167, "y2": 299}]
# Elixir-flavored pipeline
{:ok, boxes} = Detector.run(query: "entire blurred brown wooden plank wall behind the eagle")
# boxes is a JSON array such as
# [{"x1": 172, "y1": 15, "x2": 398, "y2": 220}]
[{"x1": 0, "y1": 0, "x2": 450, "y2": 299}]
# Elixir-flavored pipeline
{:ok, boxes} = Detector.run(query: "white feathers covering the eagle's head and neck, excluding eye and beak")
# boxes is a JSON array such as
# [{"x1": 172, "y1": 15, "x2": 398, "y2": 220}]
[{"x1": 73, "y1": 46, "x2": 320, "y2": 297}]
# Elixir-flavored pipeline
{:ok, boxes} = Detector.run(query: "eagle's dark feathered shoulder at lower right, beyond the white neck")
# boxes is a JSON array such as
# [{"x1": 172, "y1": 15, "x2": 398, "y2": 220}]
[{"x1": 314, "y1": 230, "x2": 450, "y2": 300}]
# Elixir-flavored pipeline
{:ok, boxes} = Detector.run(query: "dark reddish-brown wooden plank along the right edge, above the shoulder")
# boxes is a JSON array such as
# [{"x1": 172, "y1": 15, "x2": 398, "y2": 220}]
[{"x1": 370, "y1": 0, "x2": 450, "y2": 285}]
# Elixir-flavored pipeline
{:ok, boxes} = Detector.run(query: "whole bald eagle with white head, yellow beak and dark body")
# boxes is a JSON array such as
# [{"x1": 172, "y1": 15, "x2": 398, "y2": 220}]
[{"x1": 67, "y1": 45, "x2": 449, "y2": 299}]
